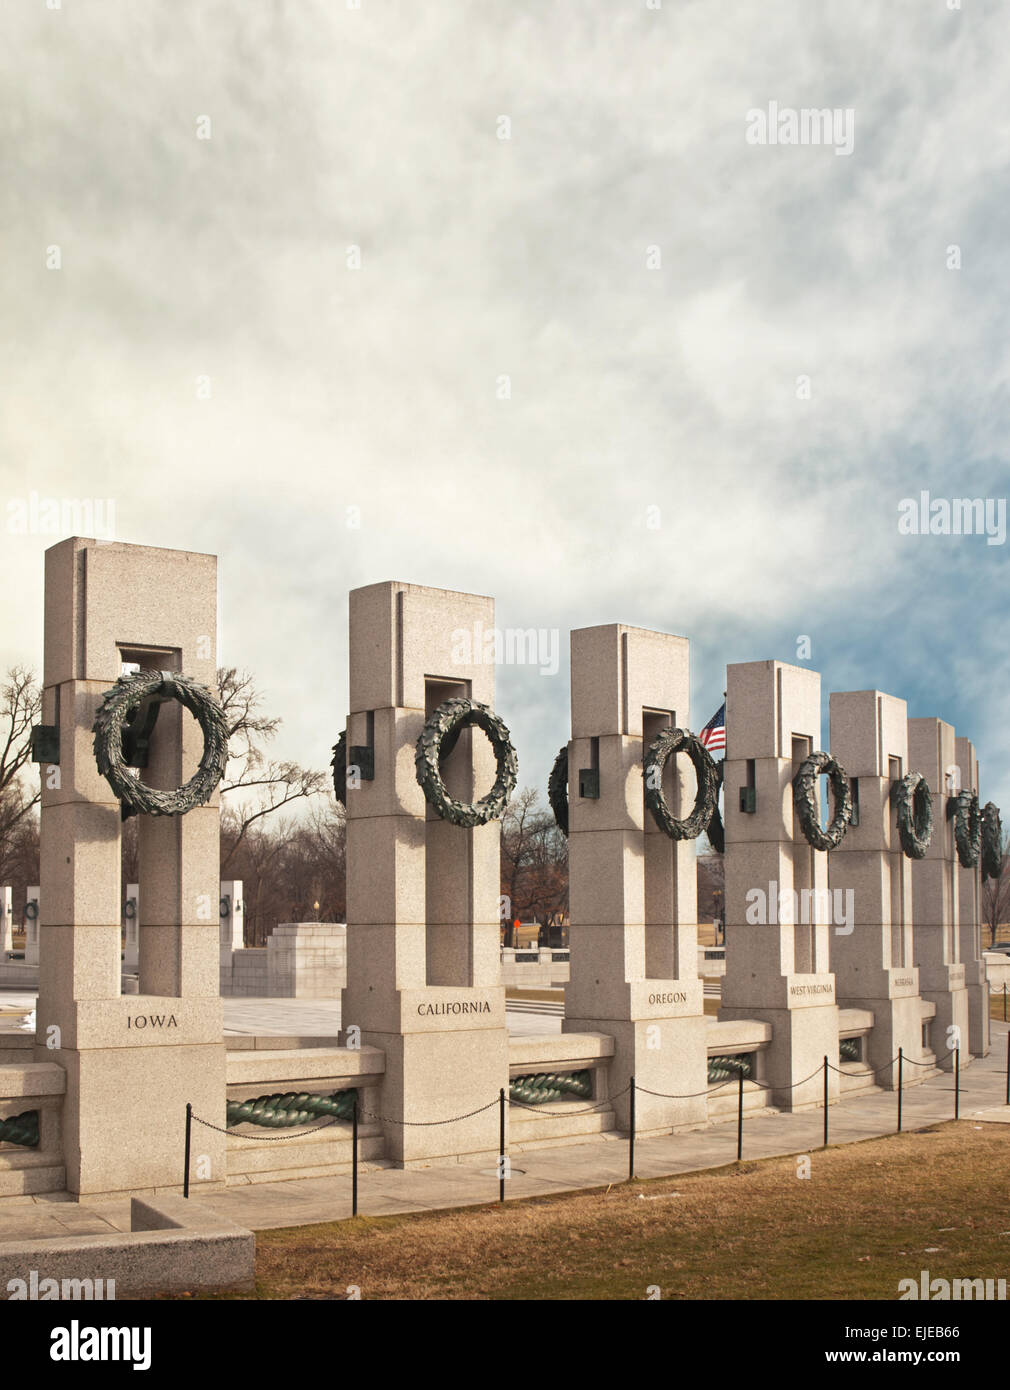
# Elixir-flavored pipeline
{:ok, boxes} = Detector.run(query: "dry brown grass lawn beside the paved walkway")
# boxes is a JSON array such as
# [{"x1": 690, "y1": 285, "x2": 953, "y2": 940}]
[{"x1": 175, "y1": 1120, "x2": 1010, "y2": 1300}]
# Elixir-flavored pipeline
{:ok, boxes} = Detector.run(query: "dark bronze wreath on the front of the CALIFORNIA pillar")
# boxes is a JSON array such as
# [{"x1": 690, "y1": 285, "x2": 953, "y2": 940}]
[{"x1": 414, "y1": 696, "x2": 520, "y2": 828}]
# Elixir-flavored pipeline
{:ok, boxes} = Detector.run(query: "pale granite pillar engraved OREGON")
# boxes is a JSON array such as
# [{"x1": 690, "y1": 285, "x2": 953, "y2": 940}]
[{"x1": 563, "y1": 623, "x2": 709, "y2": 1133}]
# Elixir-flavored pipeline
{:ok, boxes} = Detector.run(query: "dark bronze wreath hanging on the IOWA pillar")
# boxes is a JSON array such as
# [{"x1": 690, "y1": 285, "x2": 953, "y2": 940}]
[{"x1": 92, "y1": 671, "x2": 228, "y2": 819}]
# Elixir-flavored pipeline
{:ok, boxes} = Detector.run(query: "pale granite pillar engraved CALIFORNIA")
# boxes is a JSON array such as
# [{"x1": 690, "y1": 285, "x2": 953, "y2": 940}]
[{"x1": 340, "y1": 582, "x2": 508, "y2": 1168}]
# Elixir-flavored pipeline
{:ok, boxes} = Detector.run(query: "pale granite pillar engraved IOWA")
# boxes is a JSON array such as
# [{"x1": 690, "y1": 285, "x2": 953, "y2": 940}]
[{"x1": 36, "y1": 537, "x2": 226, "y2": 1194}]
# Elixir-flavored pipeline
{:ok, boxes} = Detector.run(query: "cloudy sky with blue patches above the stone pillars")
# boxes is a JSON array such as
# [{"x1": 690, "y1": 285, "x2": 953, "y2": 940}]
[{"x1": 0, "y1": 0, "x2": 1010, "y2": 806}]
